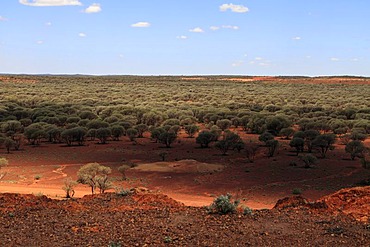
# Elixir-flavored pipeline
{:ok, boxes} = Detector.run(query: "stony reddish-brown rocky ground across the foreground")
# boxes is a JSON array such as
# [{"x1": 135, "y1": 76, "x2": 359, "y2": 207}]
[{"x1": 0, "y1": 187, "x2": 370, "y2": 246}]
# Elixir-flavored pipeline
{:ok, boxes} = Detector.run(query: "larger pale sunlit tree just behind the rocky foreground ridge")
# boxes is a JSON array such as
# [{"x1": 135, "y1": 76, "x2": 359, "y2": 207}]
[{"x1": 77, "y1": 163, "x2": 112, "y2": 194}]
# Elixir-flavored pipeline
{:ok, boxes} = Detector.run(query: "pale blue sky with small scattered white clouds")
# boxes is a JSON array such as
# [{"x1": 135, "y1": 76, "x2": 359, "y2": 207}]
[{"x1": 0, "y1": 0, "x2": 370, "y2": 76}]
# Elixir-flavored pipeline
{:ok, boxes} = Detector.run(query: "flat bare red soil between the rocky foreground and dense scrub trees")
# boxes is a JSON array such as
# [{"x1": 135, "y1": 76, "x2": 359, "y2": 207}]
[{"x1": 0, "y1": 131, "x2": 370, "y2": 208}]
